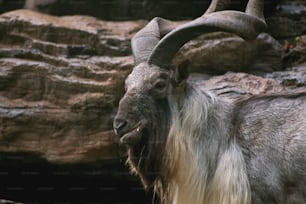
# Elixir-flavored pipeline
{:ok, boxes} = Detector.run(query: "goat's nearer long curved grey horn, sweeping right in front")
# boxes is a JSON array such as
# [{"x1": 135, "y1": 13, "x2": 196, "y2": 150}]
[{"x1": 148, "y1": 0, "x2": 266, "y2": 68}]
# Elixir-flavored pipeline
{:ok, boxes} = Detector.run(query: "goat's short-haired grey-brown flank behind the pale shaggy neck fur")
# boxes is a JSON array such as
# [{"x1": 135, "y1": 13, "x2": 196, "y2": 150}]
[{"x1": 232, "y1": 93, "x2": 306, "y2": 203}]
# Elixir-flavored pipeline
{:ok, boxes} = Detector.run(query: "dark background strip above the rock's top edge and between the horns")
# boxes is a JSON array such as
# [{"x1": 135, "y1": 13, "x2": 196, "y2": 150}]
[{"x1": 0, "y1": 0, "x2": 280, "y2": 20}]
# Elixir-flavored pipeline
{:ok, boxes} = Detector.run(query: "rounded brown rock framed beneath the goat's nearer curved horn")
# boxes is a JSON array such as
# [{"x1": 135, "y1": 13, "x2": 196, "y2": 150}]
[{"x1": 174, "y1": 33, "x2": 285, "y2": 75}]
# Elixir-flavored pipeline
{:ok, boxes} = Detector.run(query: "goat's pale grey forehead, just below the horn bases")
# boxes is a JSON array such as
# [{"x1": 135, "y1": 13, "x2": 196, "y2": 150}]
[{"x1": 125, "y1": 63, "x2": 168, "y2": 87}]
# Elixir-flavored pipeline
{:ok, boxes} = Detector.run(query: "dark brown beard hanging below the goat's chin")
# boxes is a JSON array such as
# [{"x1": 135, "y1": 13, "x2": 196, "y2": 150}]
[{"x1": 128, "y1": 99, "x2": 171, "y2": 191}]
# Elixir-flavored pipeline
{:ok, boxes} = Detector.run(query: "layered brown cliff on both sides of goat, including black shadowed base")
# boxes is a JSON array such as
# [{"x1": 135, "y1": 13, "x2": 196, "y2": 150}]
[{"x1": 0, "y1": 1, "x2": 306, "y2": 203}]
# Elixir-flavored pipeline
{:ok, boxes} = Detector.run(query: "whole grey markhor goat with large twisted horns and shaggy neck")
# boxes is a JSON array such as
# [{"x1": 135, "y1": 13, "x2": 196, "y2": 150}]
[{"x1": 114, "y1": 0, "x2": 306, "y2": 204}]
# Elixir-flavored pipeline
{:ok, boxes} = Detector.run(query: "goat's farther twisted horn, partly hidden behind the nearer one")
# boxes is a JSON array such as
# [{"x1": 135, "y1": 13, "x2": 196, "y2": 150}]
[{"x1": 131, "y1": 0, "x2": 230, "y2": 65}]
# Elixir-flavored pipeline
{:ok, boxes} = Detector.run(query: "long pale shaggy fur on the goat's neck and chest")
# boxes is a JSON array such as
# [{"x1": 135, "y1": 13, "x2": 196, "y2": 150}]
[{"x1": 155, "y1": 83, "x2": 251, "y2": 204}]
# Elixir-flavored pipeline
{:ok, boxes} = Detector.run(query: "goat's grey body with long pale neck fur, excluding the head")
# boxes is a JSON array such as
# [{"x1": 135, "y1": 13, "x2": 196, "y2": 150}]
[{"x1": 157, "y1": 80, "x2": 306, "y2": 204}]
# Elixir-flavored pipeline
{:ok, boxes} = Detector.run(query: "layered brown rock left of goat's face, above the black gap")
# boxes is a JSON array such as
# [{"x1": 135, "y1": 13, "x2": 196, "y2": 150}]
[{"x1": 0, "y1": 10, "x2": 142, "y2": 163}]
